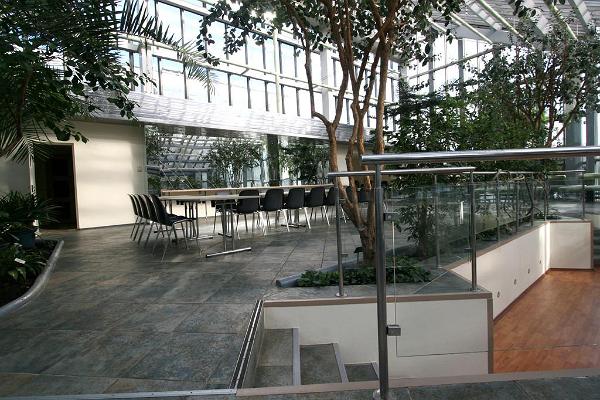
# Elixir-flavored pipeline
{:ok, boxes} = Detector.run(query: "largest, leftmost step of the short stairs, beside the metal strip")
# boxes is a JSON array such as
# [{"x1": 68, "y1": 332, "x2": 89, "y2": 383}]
[{"x1": 254, "y1": 329, "x2": 300, "y2": 387}]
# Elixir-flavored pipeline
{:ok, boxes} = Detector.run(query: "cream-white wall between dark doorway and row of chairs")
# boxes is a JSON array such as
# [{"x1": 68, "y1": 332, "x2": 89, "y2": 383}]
[{"x1": 73, "y1": 122, "x2": 147, "y2": 228}]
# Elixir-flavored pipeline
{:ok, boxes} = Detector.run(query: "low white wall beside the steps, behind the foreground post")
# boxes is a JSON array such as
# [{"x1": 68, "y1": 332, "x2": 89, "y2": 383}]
[{"x1": 264, "y1": 293, "x2": 490, "y2": 377}]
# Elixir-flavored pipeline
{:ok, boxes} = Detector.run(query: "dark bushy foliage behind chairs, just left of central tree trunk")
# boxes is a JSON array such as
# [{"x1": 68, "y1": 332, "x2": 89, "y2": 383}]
[{"x1": 280, "y1": 138, "x2": 329, "y2": 184}]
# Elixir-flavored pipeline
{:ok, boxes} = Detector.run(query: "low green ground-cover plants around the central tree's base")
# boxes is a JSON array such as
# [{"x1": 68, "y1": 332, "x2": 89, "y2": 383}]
[{"x1": 298, "y1": 265, "x2": 431, "y2": 287}]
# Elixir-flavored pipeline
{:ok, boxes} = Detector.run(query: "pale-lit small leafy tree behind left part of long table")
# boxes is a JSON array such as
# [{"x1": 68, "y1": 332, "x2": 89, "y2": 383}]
[{"x1": 207, "y1": 138, "x2": 262, "y2": 187}]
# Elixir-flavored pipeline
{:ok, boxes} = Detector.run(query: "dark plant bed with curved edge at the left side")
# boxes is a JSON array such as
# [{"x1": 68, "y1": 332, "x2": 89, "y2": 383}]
[{"x1": 0, "y1": 240, "x2": 57, "y2": 307}]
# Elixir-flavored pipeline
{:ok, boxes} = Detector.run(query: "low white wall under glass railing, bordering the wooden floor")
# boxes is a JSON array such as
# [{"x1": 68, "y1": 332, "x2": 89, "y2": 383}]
[{"x1": 452, "y1": 221, "x2": 592, "y2": 317}]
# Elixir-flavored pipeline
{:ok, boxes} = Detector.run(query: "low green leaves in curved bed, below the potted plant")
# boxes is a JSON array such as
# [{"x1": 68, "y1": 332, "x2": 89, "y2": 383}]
[{"x1": 0, "y1": 243, "x2": 48, "y2": 284}]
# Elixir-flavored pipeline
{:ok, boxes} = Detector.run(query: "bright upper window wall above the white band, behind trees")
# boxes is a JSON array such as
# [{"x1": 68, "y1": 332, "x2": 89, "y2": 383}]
[{"x1": 120, "y1": 0, "x2": 489, "y2": 128}]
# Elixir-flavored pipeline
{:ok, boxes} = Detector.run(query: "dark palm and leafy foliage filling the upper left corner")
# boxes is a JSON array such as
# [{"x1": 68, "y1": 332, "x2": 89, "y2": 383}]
[{"x1": 0, "y1": 0, "x2": 210, "y2": 161}]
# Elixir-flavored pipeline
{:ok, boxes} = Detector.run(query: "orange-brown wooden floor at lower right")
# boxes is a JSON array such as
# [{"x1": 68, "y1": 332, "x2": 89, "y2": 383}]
[{"x1": 494, "y1": 268, "x2": 600, "y2": 372}]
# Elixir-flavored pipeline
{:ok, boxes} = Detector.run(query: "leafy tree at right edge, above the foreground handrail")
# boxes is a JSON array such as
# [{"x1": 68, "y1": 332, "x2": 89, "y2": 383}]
[{"x1": 474, "y1": 22, "x2": 600, "y2": 147}]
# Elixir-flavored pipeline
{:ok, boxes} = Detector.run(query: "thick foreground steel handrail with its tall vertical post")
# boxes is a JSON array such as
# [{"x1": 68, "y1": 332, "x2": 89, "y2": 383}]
[{"x1": 356, "y1": 146, "x2": 600, "y2": 400}]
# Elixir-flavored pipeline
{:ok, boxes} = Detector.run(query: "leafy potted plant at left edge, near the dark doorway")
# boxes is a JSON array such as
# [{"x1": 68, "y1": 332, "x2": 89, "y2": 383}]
[{"x1": 0, "y1": 191, "x2": 57, "y2": 248}]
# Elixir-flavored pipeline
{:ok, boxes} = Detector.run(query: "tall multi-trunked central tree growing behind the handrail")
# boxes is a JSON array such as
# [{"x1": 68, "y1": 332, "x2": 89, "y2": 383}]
[{"x1": 198, "y1": 0, "x2": 460, "y2": 261}]
